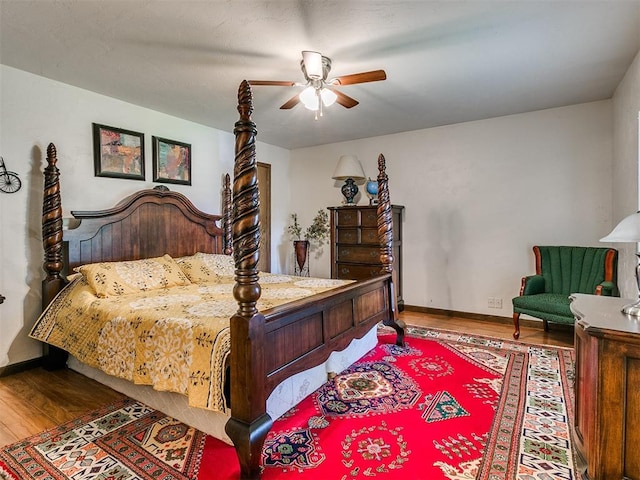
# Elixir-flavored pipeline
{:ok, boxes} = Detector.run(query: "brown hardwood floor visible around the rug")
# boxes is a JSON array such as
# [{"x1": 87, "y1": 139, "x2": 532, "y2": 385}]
[{"x1": 0, "y1": 311, "x2": 573, "y2": 447}]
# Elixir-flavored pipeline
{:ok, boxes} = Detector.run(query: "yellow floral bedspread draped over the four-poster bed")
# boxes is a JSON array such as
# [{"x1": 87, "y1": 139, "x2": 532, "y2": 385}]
[{"x1": 30, "y1": 273, "x2": 350, "y2": 412}]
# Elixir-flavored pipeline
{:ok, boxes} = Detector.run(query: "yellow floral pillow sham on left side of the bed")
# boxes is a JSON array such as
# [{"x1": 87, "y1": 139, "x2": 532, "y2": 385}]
[{"x1": 75, "y1": 255, "x2": 191, "y2": 297}]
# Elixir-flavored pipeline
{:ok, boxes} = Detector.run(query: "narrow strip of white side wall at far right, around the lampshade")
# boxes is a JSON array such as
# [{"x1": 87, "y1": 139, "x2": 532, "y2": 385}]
[{"x1": 611, "y1": 47, "x2": 640, "y2": 299}]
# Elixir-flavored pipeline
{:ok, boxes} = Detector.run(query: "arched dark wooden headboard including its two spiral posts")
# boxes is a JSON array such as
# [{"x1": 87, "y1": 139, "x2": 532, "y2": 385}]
[{"x1": 43, "y1": 144, "x2": 231, "y2": 290}]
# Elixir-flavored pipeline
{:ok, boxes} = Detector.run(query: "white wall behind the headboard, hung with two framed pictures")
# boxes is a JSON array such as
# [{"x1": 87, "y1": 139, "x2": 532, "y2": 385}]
[{"x1": 0, "y1": 65, "x2": 290, "y2": 367}]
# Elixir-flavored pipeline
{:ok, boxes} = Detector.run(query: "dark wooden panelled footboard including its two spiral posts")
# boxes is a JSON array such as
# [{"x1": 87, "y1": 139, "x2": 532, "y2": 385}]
[{"x1": 225, "y1": 81, "x2": 404, "y2": 478}]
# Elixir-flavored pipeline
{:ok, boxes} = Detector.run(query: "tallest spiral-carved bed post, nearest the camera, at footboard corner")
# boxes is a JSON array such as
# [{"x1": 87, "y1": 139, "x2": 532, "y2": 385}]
[{"x1": 225, "y1": 80, "x2": 273, "y2": 478}]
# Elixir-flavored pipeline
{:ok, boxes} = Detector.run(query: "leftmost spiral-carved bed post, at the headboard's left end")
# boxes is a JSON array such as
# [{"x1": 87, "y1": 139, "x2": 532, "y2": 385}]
[{"x1": 42, "y1": 143, "x2": 67, "y2": 370}]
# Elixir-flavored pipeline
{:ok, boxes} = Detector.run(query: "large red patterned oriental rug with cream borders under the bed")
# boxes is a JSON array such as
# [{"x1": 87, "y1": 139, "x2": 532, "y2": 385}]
[{"x1": 0, "y1": 327, "x2": 576, "y2": 480}]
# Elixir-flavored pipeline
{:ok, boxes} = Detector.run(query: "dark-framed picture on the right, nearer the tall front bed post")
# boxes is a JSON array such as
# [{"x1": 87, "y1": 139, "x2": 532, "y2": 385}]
[{"x1": 153, "y1": 137, "x2": 191, "y2": 185}]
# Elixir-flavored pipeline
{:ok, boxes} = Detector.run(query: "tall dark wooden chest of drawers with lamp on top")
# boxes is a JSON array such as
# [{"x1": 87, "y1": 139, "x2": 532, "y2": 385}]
[{"x1": 329, "y1": 205, "x2": 404, "y2": 310}]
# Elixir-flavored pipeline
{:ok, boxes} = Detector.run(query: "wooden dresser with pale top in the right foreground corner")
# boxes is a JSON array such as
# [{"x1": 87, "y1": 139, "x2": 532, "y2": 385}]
[{"x1": 571, "y1": 294, "x2": 640, "y2": 480}]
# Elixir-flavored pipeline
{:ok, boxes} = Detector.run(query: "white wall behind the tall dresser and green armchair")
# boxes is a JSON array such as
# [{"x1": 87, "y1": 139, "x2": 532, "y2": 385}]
[{"x1": 291, "y1": 101, "x2": 612, "y2": 317}]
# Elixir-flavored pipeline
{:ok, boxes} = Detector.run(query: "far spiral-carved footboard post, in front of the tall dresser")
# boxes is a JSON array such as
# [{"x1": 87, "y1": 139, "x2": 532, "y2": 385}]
[{"x1": 378, "y1": 154, "x2": 405, "y2": 347}]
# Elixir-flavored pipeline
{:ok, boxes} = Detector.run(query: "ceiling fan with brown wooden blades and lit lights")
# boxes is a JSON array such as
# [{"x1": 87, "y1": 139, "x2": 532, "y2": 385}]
[{"x1": 249, "y1": 50, "x2": 387, "y2": 119}]
